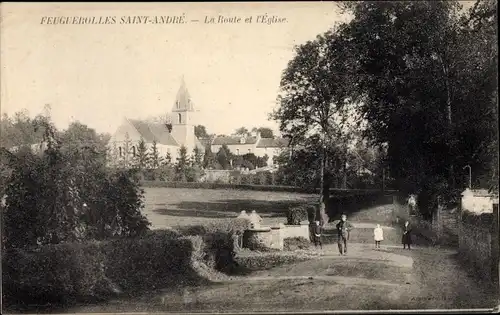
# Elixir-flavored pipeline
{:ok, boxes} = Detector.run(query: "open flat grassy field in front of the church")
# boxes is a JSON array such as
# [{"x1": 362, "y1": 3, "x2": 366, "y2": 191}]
[{"x1": 144, "y1": 187, "x2": 318, "y2": 229}]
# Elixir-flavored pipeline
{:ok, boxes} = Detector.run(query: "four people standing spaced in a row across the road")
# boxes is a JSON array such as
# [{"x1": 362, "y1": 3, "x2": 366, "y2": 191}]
[{"x1": 313, "y1": 214, "x2": 412, "y2": 255}]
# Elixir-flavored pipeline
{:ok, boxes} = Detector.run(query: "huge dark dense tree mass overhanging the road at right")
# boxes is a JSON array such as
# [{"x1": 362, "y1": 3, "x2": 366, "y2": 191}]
[{"x1": 341, "y1": 1, "x2": 498, "y2": 209}]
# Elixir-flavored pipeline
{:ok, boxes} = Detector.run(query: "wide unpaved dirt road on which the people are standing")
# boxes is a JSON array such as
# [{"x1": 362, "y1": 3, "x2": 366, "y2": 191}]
[{"x1": 67, "y1": 207, "x2": 500, "y2": 312}]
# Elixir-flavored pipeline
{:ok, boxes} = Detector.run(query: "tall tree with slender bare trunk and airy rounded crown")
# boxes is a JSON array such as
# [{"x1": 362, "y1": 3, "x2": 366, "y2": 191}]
[{"x1": 272, "y1": 31, "x2": 354, "y2": 223}]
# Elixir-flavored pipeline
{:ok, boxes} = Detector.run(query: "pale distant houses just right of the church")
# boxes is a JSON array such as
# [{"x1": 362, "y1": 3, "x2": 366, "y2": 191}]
[{"x1": 210, "y1": 132, "x2": 288, "y2": 166}]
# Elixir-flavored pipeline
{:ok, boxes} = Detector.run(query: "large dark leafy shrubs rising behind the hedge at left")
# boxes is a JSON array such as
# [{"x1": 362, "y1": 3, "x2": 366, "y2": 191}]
[{"x1": 3, "y1": 116, "x2": 150, "y2": 248}]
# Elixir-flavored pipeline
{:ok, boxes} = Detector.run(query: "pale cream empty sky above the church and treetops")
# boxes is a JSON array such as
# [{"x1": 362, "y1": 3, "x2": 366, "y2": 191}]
[{"x1": 0, "y1": 2, "x2": 347, "y2": 134}]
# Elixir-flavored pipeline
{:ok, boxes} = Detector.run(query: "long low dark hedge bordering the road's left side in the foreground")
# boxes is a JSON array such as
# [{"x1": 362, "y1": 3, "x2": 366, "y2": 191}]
[{"x1": 2, "y1": 220, "x2": 248, "y2": 312}]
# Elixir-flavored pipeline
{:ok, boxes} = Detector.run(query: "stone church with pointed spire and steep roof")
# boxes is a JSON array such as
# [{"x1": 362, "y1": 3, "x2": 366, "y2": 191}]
[{"x1": 109, "y1": 79, "x2": 205, "y2": 165}]
